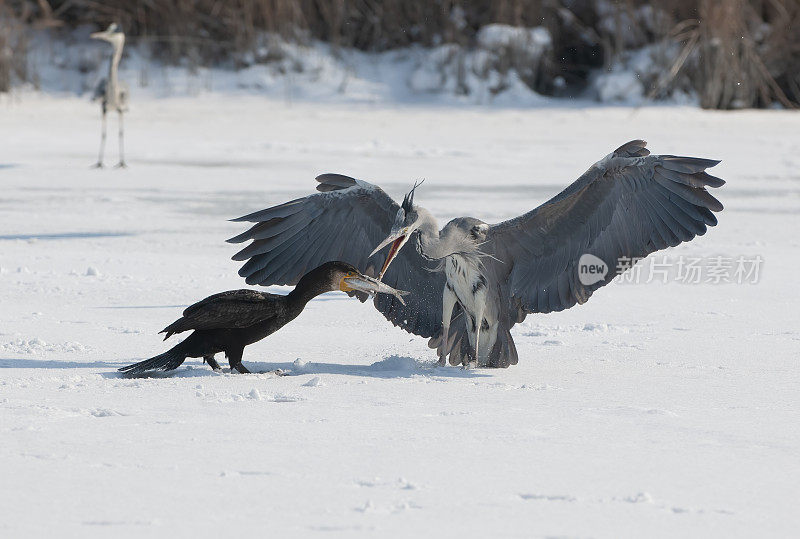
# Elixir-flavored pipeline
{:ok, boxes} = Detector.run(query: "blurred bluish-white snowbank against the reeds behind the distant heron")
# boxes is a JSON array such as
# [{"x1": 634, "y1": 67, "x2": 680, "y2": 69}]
[{"x1": 14, "y1": 28, "x2": 552, "y2": 106}]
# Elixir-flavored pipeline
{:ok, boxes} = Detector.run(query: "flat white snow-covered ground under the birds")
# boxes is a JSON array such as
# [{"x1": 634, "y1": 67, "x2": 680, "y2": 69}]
[{"x1": 0, "y1": 94, "x2": 800, "y2": 537}]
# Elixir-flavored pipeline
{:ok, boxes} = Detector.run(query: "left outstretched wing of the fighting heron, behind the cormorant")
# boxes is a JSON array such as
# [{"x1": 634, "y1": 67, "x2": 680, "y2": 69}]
[{"x1": 228, "y1": 174, "x2": 444, "y2": 337}]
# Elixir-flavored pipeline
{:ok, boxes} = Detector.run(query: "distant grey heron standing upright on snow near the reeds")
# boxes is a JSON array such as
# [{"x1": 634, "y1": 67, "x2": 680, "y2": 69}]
[{"x1": 91, "y1": 23, "x2": 128, "y2": 168}]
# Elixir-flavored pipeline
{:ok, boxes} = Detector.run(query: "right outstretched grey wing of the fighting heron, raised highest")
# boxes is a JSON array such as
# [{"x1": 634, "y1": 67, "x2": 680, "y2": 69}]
[{"x1": 483, "y1": 140, "x2": 725, "y2": 321}]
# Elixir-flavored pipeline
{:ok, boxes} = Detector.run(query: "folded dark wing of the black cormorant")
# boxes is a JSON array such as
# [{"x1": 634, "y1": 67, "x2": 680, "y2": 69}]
[{"x1": 161, "y1": 289, "x2": 284, "y2": 339}]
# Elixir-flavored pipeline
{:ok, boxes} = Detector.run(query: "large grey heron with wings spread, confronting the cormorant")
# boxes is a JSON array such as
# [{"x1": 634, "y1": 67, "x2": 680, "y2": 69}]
[{"x1": 228, "y1": 140, "x2": 724, "y2": 367}]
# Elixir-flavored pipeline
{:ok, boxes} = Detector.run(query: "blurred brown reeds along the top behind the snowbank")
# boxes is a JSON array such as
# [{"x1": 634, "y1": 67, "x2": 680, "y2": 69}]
[{"x1": 0, "y1": 0, "x2": 800, "y2": 109}]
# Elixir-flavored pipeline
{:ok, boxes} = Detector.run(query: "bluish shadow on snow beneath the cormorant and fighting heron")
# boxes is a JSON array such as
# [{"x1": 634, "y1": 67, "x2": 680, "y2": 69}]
[{"x1": 101, "y1": 355, "x2": 489, "y2": 378}]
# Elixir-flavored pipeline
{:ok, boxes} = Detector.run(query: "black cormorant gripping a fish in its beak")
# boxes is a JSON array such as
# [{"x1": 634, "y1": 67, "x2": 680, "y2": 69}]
[{"x1": 119, "y1": 262, "x2": 405, "y2": 375}]
